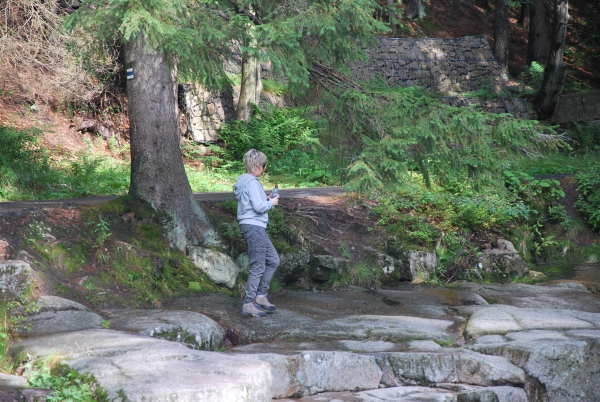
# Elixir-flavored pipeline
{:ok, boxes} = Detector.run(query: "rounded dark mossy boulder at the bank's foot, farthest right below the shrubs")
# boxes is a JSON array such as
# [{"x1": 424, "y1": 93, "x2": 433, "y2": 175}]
[{"x1": 479, "y1": 239, "x2": 529, "y2": 281}]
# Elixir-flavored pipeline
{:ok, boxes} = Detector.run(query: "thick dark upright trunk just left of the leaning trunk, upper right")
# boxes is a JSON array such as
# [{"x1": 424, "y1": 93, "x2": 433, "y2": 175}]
[{"x1": 527, "y1": 0, "x2": 554, "y2": 66}]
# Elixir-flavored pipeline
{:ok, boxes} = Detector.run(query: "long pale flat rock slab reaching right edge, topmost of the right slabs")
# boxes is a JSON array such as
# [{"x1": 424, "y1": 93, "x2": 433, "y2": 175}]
[{"x1": 461, "y1": 305, "x2": 600, "y2": 338}]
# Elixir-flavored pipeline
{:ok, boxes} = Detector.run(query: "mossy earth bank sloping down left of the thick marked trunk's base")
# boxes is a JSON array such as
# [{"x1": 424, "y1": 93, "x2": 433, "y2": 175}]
[{"x1": 2, "y1": 196, "x2": 231, "y2": 308}]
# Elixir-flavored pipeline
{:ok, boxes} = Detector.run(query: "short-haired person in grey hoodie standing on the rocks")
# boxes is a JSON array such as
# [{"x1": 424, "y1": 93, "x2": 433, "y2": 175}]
[{"x1": 233, "y1": 149, "x2": 279, "y2": 317}]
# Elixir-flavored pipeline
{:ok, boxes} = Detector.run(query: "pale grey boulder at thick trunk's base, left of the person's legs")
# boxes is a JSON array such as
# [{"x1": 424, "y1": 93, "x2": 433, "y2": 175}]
[{"x1": 188, "y1": 246, "x2": 239, "y2": 289}]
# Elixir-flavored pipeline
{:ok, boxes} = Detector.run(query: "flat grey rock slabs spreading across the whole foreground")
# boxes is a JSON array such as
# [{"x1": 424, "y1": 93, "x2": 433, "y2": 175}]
[{"x1": 0, "y1": 261, "x2": 600, "y2": 402}]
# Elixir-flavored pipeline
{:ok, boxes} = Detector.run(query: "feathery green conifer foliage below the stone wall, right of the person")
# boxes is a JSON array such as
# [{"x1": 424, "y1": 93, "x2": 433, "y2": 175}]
[{"x1": 328, "y1": 85, "x2": 566, "y2": 192}]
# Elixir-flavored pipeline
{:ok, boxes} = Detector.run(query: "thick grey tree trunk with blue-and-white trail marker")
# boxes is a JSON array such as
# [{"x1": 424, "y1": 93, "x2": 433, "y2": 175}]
[{"x1": 125, "y1": 33, "x2": 214, "y2": 250}]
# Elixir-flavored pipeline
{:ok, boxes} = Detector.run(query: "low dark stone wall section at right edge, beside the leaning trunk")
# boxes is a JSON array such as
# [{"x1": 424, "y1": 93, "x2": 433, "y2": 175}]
[{"x1": 552, "y1": 91, "x2": 600, "y2": 124}]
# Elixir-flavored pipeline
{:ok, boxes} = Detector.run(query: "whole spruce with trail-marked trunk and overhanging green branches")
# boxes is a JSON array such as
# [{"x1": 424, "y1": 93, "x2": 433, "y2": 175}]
[{"x1": 66, "y1": 0, "x2": 386, "y2": 250}]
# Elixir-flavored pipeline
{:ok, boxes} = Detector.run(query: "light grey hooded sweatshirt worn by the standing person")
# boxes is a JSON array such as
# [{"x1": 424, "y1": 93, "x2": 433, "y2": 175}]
[{"x1": 233, "y1": 173, "x2": 273, "y2": 228}]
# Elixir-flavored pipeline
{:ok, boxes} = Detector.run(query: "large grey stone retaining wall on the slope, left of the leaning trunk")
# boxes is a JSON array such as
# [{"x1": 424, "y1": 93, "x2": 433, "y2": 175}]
[{"x1": 353, "y1": 36, "x2": 529, "y2": 119}]
